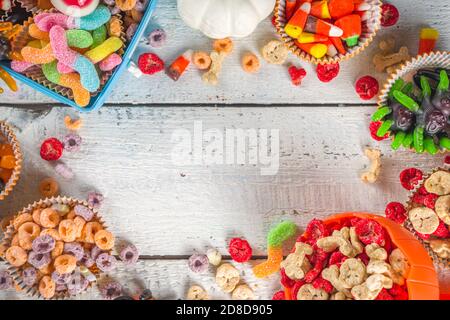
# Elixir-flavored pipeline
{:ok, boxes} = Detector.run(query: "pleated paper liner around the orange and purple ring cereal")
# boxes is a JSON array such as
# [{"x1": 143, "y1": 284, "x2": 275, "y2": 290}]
[{"x1": 0, "y1": 197, "x2": 112, "y2": 300}]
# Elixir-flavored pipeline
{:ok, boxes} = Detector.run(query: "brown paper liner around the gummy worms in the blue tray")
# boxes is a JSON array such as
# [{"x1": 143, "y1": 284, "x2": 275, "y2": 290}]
[{"x1": 11, "y1": 9, "x2": 127, "y2": 104}]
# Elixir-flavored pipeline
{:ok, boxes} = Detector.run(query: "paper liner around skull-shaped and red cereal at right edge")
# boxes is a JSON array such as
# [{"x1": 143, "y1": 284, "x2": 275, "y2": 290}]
[{"x1": 404, "y1": 166, "x2": 450, "y2": 269}]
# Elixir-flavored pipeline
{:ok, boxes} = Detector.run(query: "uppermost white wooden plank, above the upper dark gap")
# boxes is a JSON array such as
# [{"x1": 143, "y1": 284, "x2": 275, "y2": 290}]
[{"x1": 0, "y1": 0, "x2": 450, "y2": 105}]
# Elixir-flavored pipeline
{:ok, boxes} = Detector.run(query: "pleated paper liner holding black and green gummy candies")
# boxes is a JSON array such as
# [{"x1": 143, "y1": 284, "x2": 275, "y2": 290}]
[{"x1": 378, "y1": 51, "x2": 450, "y2": 153}]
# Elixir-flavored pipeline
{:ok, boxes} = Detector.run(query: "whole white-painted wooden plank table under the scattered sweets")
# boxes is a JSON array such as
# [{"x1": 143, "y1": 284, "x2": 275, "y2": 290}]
[{"x1": 0, "y1": 0, "x2": 450, "y2": 299}]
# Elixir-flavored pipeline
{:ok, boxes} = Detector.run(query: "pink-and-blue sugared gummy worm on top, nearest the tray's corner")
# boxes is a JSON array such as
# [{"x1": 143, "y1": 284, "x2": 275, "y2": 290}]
[{"x1": 50, "y1": 26, "x2": 100, "y2": 92}]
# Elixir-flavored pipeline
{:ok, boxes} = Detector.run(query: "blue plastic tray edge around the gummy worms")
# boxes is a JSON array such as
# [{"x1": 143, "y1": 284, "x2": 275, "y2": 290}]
[{"x1": 0, "y1": 0, "x2": 158, "y2": 112}]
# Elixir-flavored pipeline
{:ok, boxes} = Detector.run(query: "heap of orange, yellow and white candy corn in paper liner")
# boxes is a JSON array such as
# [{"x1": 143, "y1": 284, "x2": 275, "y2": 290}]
[{"x1": 284, "y1": 0, "x2": 372, "y2": 59}]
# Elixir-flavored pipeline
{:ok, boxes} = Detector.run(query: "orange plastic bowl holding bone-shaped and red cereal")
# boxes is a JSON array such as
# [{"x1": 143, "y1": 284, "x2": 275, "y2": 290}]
[{"x1": 285, "y1": 212, "x2": 439, "y2": 300}]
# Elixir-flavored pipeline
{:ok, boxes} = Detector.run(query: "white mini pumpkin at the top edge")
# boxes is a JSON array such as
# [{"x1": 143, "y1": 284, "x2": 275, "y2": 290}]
[{"x1": 178, "y1": 0, "x2": 276, "y2": 39}]
